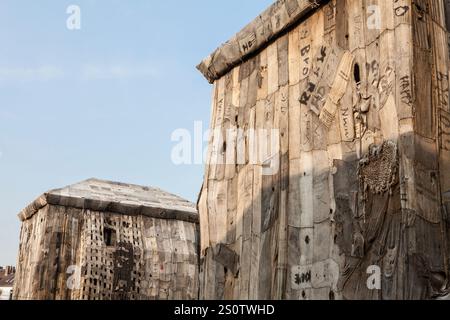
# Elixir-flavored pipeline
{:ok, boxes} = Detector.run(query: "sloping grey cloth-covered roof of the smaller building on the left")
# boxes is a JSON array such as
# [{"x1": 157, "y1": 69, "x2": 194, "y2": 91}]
[{"x1": 19, "y1": 178, "x2": 198, "y2": 223}]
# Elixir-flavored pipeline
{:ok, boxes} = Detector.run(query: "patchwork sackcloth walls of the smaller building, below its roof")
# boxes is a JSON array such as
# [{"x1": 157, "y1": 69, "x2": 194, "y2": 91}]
[{"x1": 14, "y1": 205, "x2": 199, "y2": 300}]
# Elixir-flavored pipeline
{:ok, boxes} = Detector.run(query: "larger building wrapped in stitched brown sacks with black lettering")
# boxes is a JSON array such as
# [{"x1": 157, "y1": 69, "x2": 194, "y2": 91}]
[{"x1": 199, "y1": 0, "x2": 450, "y2": 299}]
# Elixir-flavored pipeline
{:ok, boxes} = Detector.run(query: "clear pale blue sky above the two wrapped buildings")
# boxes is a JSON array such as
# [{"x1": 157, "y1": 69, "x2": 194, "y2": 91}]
[{"x1": 0, "y1": 0, "x2": 272, "y2": 265}]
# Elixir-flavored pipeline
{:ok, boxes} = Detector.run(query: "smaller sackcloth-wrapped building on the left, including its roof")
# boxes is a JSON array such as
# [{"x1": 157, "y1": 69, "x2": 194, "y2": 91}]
[{"x1": 13, "y1": 179, "x2": 199, "y2": 300}]
